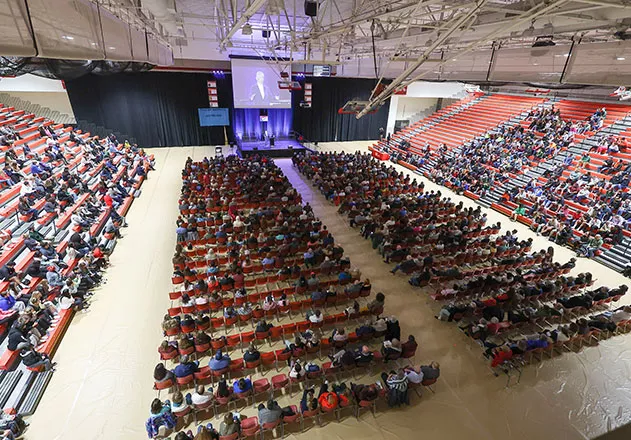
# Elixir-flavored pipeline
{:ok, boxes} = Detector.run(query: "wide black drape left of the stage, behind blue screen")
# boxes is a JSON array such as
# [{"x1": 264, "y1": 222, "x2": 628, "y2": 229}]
[{"x1": 66, "y1": 72, "x2": 233, "y2": 147}]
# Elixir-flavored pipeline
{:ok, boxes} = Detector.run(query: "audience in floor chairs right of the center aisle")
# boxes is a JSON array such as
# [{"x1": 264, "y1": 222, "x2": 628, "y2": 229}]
[{"x1": 295, "y1": 150, "x2": 628, "y2": 372}]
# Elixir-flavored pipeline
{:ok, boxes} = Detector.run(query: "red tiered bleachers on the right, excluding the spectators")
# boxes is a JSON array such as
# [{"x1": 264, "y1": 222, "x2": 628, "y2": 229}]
[{"x1": 371, "y1": 95, "x2": 631, "y2": 270}]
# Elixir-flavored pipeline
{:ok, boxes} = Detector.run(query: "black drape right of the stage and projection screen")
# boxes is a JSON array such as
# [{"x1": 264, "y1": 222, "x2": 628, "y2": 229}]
[{"x1": 292, "y1": 78, "x2": 390, "y2": 142}]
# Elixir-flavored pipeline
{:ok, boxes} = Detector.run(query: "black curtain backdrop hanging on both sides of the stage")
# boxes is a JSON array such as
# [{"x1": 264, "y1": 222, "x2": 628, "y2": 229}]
[{"x1": 66, "y1": 72, "x2": 389, "y2": 147}]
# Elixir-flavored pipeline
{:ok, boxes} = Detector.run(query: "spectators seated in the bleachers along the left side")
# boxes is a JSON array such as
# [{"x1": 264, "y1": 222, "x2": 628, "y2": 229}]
[{"x1": 0, "y1": 106, "x2": 153, "y2": 382}]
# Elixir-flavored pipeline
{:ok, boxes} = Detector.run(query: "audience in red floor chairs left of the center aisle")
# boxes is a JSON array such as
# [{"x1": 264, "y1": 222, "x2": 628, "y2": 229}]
[{"x1": 146, "y1": 157, "x2": 440, "y2": 440}]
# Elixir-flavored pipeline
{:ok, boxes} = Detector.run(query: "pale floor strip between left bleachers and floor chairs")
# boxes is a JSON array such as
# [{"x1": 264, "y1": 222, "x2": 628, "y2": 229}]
[{"x1": 26, "y1": 148, "x2": 214, "y2": 440}]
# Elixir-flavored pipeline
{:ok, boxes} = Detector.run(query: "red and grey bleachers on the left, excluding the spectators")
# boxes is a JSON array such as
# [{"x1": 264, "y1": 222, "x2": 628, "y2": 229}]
[{"x1": 0, "y1": 99, "x2": 153, "y2": 414}]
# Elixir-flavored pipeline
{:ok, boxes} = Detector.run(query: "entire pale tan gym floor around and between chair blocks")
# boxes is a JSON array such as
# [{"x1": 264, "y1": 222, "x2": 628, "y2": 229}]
[{"x1": 26, "y1": 142, "x2": 631, "y2": 440}]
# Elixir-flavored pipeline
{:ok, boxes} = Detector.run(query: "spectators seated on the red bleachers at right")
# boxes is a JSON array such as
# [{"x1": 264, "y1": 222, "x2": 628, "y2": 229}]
[{"x1": 380, "y1": 99, "x2": 631, "y2": 257}]
